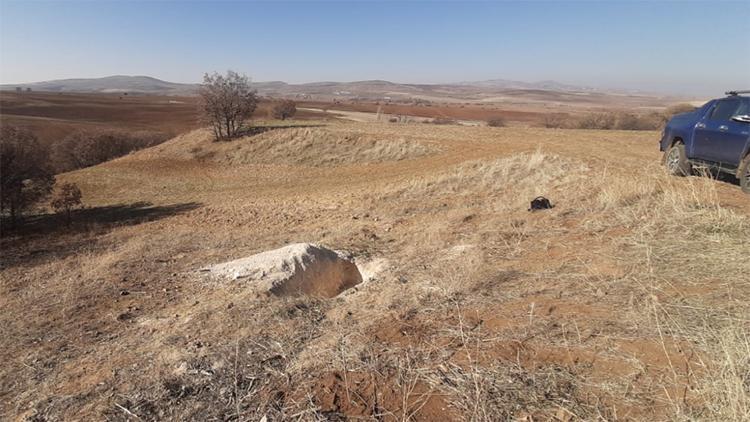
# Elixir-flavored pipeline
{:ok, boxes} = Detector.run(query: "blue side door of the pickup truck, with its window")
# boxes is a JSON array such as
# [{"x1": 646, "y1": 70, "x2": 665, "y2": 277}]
[{"x1": 693, "y1": 98, "x2": 748, "y2": 166}]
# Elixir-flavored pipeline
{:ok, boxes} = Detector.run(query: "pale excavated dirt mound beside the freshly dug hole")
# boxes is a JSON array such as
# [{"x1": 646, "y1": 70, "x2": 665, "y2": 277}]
[{"x1": 208, "y1": 243, "x2": 362, "y2": 298}]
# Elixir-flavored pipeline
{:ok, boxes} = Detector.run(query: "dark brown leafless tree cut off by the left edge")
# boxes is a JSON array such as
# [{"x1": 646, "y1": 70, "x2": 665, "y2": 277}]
[{"x1": 0, "y1": 126, "x2": 55, "y2": 224}]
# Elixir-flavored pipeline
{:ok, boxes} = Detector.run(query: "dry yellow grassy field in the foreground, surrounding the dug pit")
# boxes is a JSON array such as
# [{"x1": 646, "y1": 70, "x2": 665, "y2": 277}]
[{"x1": 0, "y1": 117, "x2": 750, "y2": 421}]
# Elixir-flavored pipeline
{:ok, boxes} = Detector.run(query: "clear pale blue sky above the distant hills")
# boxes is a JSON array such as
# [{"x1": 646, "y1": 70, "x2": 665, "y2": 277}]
[{"x1": 0, "y1": 0, "x2": 750, "y2": 94}]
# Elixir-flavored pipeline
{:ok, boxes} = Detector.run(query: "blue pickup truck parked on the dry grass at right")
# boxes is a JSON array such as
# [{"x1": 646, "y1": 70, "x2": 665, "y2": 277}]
[{"x1": 659, "y1": 91, "x2": 750, "y2": 193}]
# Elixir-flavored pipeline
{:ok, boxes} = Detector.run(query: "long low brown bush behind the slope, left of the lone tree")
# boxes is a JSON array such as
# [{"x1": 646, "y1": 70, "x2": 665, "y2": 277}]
[{"x1": 52, "y1": 130, "x2": 168, "y2": 173}]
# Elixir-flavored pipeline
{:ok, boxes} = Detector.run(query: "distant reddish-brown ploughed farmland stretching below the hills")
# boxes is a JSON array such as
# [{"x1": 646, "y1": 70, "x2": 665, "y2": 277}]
[{"x1": 0, "y1": 91, "x2": 679, "y2": 152}]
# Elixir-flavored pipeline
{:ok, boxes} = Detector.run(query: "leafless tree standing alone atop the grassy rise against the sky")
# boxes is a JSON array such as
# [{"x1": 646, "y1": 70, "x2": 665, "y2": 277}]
[{"x1": 200, "y1": 70, "x2": 258, "y2": 140}]
